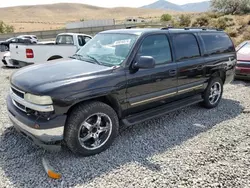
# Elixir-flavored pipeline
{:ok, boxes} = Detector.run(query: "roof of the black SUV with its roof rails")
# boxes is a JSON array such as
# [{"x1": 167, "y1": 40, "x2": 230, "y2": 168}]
[{"x1": 100, "y1": 28, "x2": 223, "y2": 35}]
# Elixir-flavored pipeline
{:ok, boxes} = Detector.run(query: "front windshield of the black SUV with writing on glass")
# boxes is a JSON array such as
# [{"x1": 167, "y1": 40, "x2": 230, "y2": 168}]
[{"x1": 75, "y1": 34, "x2": 138, "y2": 66}]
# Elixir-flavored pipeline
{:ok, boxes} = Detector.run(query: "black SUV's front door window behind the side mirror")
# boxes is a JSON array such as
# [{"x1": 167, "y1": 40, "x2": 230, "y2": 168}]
[{"x1": 138, "y1": 34, "x2": 172, "y2": 65}]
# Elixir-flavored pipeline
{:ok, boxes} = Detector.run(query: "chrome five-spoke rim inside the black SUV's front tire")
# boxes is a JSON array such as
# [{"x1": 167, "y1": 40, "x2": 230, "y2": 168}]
[{"x1": 78, "y1": 113, "x2": 112, "y2": 150}]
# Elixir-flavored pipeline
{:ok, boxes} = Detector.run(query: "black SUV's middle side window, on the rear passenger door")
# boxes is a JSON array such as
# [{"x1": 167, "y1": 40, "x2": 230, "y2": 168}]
[{"x1": 174, "y1": 34, "x2": 200, "y2": 61}]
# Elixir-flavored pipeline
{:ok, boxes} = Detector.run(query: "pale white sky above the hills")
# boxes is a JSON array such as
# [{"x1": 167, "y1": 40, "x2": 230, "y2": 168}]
[{"x1": 0, "y1": 0, "x2": 207, "y2": 7}]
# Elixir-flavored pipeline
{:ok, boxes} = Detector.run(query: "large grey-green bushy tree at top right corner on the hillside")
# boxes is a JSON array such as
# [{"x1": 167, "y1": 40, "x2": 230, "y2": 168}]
[{"x1": 211, "y1": 0, "x2": 250, "y2": 14}]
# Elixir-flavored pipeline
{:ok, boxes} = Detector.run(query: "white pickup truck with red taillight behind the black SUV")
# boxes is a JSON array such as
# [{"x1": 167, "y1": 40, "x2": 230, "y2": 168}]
[{"x1": 10, "y1": 33, "x2": 92, "y2": 67}]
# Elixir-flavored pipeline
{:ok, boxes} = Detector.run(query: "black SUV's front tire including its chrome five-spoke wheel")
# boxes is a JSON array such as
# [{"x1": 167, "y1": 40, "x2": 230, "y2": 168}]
[{"x1": 64, "y1": 101, "x2": 119, "y2": 156}]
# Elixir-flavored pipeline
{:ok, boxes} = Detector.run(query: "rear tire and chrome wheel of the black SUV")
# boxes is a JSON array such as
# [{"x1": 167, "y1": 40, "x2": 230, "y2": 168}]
[{"x1": 202, "y1": 77, "x2": 223, "y2": 109}]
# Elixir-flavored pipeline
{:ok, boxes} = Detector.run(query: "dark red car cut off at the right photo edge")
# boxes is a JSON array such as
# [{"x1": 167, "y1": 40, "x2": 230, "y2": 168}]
[{"x1": 235, "y1": 41, "x2": 250, "y2": 79}]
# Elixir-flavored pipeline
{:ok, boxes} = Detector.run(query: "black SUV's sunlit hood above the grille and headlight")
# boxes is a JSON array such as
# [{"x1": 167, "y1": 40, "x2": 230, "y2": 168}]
[{"x1": 11, "y1": 59, "x2": 113, "y2": 94}]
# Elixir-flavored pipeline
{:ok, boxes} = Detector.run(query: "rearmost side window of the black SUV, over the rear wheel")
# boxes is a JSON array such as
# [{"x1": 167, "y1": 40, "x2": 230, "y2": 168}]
[{"x1": 201, "y1": 33, "x2": 235, "y2": 55}]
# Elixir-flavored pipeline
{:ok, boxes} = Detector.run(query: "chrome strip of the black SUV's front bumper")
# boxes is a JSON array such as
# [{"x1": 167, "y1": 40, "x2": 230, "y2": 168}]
[{"x1": 8, "y1": 112, "x2": 64, "y2": 142}]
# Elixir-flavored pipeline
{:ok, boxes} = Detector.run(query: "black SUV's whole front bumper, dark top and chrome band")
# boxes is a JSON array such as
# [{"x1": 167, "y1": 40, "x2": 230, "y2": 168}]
[{"x1": 7, "y1": 96, "x2": 66, "y2": 145}]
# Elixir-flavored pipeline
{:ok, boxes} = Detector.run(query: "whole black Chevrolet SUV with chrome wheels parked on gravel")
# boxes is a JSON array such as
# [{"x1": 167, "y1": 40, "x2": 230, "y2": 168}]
[{"x1": 7, "y1": 28, "x2": 236, "y2": 156}]
